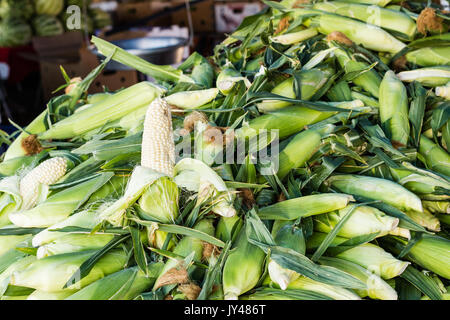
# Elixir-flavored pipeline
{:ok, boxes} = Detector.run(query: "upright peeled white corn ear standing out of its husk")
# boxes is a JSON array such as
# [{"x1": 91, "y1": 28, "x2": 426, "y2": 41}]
[{"x1": 141, "y1": 98, "x2": 175, "y2": 177}]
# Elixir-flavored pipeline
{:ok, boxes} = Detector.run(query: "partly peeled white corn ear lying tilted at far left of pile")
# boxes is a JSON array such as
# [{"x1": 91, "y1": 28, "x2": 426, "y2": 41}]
[{"x1": 20, "y1": 157, "x2": 67, "y2": 209}]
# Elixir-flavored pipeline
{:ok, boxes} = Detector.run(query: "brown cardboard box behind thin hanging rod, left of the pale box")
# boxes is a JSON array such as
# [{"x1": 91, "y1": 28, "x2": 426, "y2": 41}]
[{"x1": 172, "y1": 0, "x2": 215, "y2": 32}]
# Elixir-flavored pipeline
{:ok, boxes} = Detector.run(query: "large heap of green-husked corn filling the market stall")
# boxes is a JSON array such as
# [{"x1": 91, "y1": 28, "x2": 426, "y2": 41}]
[{"x1": 0, "y1": 0, "x2": 450, "y2": 300}]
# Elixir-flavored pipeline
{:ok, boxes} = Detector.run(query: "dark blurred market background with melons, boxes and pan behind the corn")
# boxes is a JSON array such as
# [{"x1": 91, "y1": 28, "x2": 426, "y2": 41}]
[{"x1": 0, "y1": 0, "x2": 263, "y2": 133}]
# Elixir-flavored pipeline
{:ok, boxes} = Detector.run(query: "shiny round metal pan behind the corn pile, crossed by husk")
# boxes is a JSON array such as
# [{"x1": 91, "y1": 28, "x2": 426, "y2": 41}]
[{"x1": 90, "y1": 37, "x2": 188, "y2": 71}]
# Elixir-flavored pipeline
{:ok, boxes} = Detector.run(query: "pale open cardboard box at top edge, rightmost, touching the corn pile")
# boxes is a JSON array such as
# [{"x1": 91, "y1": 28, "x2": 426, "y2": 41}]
[{"x1": 214, "y1": 1, "x2": 262, "y2": 32}]
